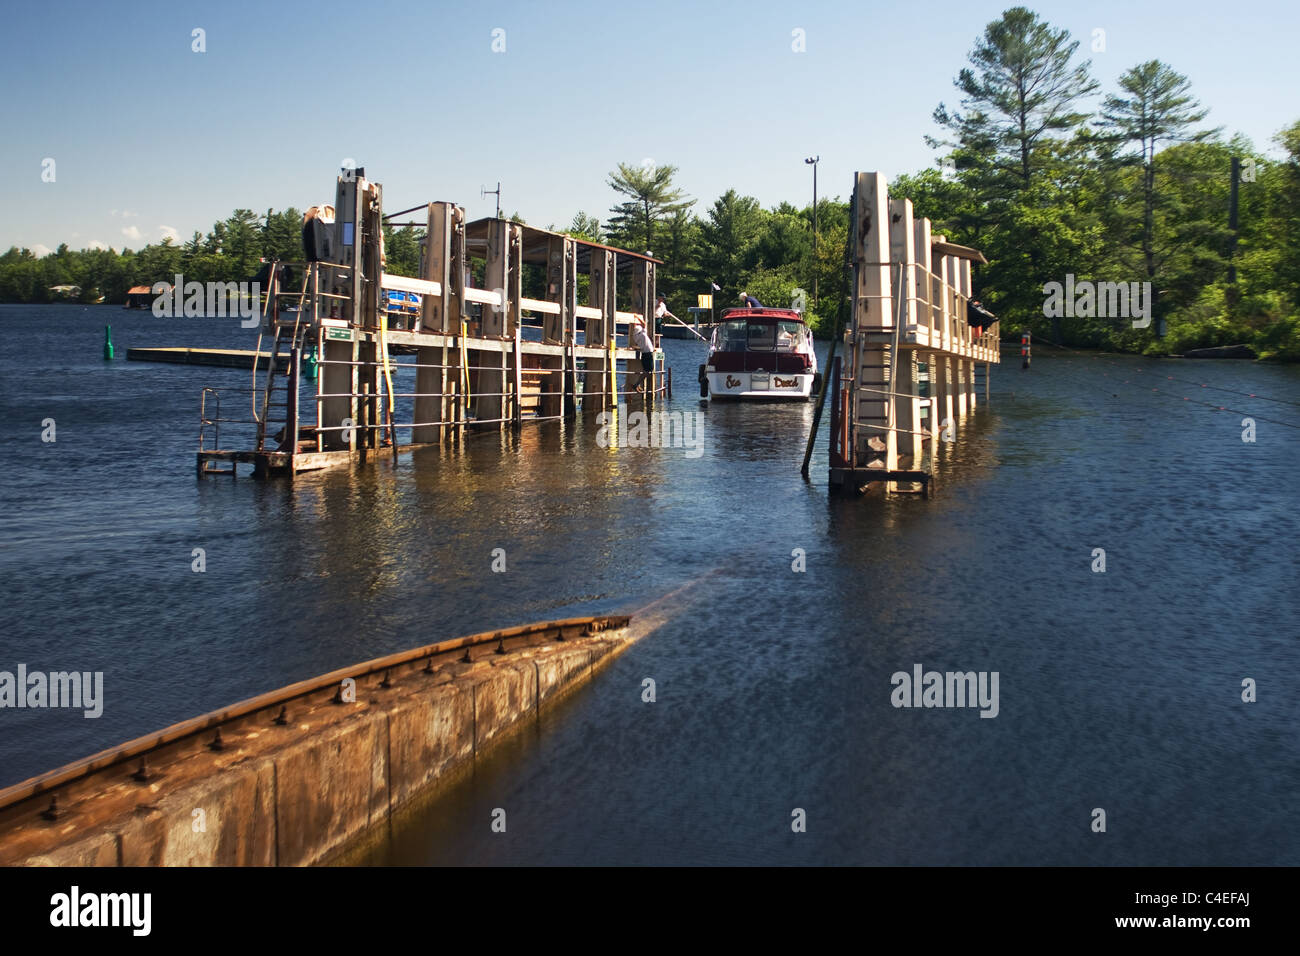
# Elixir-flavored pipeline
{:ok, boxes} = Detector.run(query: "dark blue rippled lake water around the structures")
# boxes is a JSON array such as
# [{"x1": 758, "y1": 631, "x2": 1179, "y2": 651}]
[{"x1": 0, "y1": 306, "x2": 1300, "y2": 865}]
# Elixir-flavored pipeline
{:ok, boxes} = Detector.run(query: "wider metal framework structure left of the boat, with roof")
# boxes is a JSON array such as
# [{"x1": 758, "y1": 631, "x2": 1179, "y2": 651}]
[{"x1": 205, "y1": 169, "x2": 672, "y2": 476}]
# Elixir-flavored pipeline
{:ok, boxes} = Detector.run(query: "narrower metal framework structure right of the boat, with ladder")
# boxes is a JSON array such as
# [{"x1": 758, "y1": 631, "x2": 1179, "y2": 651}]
[{"x1": 829, "y1": 173, "x2": 1000, "y2": 494}]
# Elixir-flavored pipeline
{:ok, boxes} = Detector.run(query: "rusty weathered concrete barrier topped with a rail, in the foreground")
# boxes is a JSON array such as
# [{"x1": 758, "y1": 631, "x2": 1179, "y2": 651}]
[{"x1": 0, "y1": 617, "x2": 632, "y2": 866}]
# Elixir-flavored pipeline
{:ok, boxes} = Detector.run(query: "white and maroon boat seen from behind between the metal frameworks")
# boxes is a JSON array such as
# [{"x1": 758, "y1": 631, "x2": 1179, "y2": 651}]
[{"x1": 699, "y1": 308, "x2": 820, "y2": 401}]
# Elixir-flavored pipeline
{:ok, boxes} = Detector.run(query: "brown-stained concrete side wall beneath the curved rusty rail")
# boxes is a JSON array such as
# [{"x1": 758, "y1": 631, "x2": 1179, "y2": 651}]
[{"x1": 0, "y1": 628, "x2": 631, "y2": 866}]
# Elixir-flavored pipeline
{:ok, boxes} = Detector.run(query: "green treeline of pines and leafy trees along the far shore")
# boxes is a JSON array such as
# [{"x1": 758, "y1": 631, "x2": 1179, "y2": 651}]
[{"x1": 10, "y1": 7, "x2": 1300, "y2": 359}]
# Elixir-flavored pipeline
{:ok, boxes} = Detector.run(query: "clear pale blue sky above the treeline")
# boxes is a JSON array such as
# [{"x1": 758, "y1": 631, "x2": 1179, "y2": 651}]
[{"x1": 0, "y1": 0, "x2": 1300, "y2": 255}]
